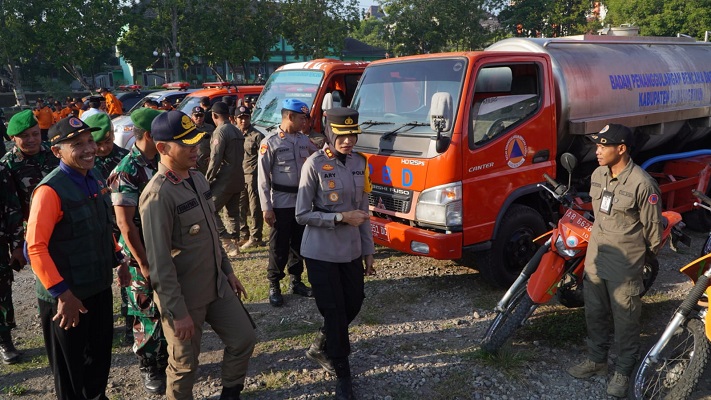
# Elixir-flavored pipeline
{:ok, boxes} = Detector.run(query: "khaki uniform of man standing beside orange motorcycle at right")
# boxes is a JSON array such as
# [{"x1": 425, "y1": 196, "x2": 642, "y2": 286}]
[{"x1": 583, "y1": 160, "x2": 663, "y2": 376}]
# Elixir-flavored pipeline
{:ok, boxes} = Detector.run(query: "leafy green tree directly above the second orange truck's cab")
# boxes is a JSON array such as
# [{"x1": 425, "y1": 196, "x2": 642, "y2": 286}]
[{"x1": 282, "y1": 0, "x2": 359, "y2": 58}]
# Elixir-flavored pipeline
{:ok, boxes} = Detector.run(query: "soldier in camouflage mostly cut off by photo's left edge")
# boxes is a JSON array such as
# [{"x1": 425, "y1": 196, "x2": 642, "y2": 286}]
[{"x1": 0, "y1": 164, "x2": 25, "y2": 364}]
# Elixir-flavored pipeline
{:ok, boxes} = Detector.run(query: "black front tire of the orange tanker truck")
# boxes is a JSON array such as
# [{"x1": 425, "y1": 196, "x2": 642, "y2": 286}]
[{"x1": 478, "y1": 204, "x2": 546, "y2": 288}]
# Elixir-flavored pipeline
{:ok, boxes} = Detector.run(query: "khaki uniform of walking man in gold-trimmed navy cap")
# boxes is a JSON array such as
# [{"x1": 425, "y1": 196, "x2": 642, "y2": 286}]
[{"x1": 139, "y1": 164, "x2": 256, "y2": 399}]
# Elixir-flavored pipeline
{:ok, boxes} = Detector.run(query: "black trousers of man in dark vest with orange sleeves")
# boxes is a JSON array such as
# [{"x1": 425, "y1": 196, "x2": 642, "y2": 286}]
[{"x1": 38, "y1": 289, "x2": 113, "y2": 400}]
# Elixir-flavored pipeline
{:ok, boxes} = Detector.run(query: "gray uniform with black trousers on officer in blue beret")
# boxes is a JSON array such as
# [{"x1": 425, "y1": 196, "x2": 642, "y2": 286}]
[{"x1": 258, "y1": 129, "x2": 317, "y2": 282}]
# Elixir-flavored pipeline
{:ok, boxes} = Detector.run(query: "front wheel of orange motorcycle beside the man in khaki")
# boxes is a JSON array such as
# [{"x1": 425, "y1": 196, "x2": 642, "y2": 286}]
[{"x1": 481, "y1": 285, "x2": 538, "y2": 354}]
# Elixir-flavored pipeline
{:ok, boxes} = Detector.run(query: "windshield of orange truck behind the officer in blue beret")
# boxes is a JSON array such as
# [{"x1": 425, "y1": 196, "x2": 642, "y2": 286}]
[{"x1": 252, "y1": 70, "x2": 323, "y2": 126}]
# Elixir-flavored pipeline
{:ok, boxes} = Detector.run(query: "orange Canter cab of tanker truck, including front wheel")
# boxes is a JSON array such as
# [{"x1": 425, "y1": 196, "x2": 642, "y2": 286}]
[{"x1": 352, "y1": 52, "x2": 557, "y2": 286}]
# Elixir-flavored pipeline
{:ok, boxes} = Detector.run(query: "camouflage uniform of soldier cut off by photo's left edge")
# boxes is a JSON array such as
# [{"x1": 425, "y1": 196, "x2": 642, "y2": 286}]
[{"x1": 0, "y1": 164, "x2": 23, "y2": 332}]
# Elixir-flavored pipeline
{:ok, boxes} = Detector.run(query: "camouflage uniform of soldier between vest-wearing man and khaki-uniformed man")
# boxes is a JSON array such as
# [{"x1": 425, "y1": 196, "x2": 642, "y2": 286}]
[{"x1": 106, "y1": 144, "x2": 167, "y2": 360}]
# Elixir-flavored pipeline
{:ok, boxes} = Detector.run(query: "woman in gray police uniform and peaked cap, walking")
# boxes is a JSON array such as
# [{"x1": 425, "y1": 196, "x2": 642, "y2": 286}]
[{"x1": 296, "y1": 108, "x2": 375, "y2": 399}]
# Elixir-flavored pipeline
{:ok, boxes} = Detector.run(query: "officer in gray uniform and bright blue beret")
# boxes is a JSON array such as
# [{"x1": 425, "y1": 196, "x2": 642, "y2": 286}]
[{"x1": 258, "y1": 99, "x2": 316, "y2": 307}]
